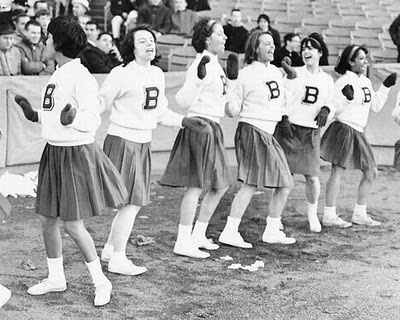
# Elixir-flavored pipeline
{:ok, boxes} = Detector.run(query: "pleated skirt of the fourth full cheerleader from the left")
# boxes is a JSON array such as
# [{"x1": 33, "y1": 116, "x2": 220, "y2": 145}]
[{"x1": 235, "y1": 122, "x2": 293, "y2": 188}]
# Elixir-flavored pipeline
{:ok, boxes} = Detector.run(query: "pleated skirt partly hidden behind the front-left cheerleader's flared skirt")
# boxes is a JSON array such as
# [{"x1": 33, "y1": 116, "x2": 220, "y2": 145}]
[{"x1": 103, "y1": 135, "x2": 151, "y2": 206}]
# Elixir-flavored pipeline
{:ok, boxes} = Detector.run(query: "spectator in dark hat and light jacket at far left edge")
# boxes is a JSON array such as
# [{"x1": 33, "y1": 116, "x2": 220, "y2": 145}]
[{"x1": 0, "y1": 24, "x2": 22, "y2": 76}]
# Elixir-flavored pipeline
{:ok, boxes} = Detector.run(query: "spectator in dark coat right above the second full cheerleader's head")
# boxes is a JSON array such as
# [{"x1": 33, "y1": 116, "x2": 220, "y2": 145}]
[{"x1": 137, "y1": 0, "x2": 172, "y2": 37}]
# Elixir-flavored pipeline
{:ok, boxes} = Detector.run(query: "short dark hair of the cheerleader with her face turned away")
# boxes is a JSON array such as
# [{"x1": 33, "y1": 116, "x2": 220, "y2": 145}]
[{"x1": 47, "y1": 16, "x2": 87, "y2": 59}]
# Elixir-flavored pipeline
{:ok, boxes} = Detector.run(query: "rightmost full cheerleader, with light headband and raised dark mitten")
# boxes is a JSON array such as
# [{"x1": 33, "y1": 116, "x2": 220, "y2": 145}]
[{"x1": 321, "y1": 45, "x2": 397, "y2": 228}]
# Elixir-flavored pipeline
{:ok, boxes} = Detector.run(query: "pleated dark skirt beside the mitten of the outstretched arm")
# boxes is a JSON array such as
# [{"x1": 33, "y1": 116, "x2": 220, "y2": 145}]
[{"x1": 160, "y1": 118, "x2": 230, "y2": 188}]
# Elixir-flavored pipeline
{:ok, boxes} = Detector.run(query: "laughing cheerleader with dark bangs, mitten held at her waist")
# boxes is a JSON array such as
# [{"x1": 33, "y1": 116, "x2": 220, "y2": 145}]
[{"x1": 275, "y1": 37, "x2": 334, "y2": 232}]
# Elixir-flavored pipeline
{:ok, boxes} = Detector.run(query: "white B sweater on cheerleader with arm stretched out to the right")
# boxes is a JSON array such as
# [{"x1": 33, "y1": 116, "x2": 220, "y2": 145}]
[{"x1": 98, "y1": 61, "x2": 184, "y2": 143}]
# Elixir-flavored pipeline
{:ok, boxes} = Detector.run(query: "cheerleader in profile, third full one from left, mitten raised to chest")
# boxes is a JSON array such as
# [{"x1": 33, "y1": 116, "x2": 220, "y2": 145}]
[{"x1": 160, "y1": 19, "x2": 229, "y2": 258}]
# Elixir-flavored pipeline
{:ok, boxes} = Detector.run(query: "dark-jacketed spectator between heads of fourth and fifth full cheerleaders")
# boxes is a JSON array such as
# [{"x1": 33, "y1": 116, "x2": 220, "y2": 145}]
[{"x1": 272, "y1": 32, "x2": 304, "y2": 67}]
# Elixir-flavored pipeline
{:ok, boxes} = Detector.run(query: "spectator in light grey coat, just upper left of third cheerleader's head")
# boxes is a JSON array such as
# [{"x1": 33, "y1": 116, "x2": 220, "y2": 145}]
[{"x1": 170, "y1": 0, "x2": 199, "y2": 36}]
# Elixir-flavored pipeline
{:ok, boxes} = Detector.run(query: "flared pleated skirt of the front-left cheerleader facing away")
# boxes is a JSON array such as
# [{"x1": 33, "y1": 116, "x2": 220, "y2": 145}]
[{"x1": 36, "y1": 143, "x2": 127, "y2": 221}]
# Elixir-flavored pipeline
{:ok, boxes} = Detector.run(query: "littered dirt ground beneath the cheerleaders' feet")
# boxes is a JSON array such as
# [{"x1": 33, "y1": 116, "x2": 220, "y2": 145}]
[{"x1": 0, "y1": 167, "x2": 400, "y2": 320}]
